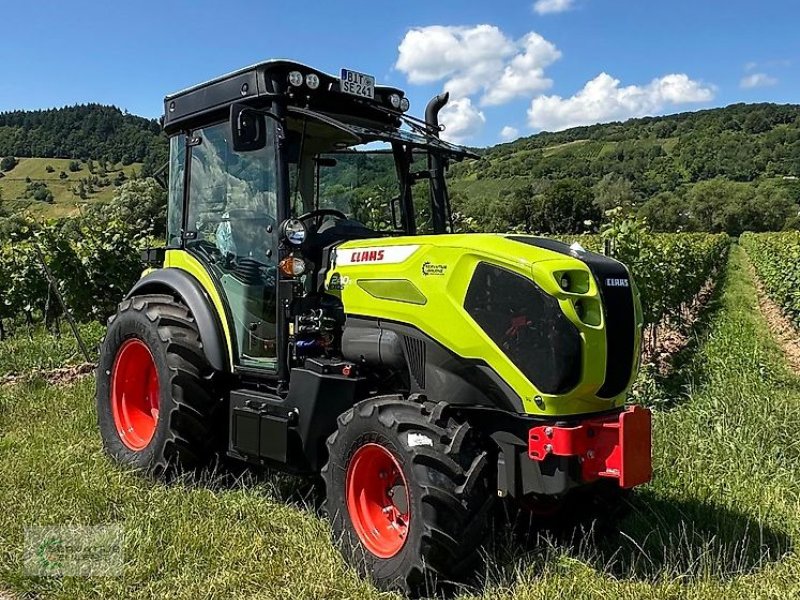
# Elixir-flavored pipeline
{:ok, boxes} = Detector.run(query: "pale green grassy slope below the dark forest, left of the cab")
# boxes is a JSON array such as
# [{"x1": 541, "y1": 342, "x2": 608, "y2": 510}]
[{"x1": 0, "y1": 158, "x2": 141, "y2": 218}]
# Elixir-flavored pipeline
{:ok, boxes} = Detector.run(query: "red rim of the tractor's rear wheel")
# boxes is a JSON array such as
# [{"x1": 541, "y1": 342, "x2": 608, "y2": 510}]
[{"x1": 111, "y1": 338, "x2": 159, "y2": 452}]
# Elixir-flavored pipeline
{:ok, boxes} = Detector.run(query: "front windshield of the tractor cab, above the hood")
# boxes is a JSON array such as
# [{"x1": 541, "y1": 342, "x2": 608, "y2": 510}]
[{"x1": 285, "y1": 109, "x2": 470, "y2": 234}]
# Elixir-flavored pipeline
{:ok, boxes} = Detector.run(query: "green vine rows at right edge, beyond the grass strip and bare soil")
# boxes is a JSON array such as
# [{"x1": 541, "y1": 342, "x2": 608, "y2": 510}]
[{"x1": 740, "y1": 231, "x2": 800, "y2": 326}]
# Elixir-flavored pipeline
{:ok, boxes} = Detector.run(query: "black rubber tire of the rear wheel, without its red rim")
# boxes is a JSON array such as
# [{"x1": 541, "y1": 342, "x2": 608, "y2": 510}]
[{"x1": 96, "y1": 295, "x2": 225, "y2": 477}]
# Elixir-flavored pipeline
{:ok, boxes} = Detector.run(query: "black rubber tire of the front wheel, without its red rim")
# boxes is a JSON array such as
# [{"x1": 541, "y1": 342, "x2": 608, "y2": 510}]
[{"x1": 322, "y1": 396, "x2": 496, "y2": 595}]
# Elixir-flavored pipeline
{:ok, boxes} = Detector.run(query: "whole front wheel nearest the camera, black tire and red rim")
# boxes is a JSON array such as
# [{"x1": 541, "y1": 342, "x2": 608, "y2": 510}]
[{"x1": 322, "y1": 396, "x2": 494, "y2": 594}]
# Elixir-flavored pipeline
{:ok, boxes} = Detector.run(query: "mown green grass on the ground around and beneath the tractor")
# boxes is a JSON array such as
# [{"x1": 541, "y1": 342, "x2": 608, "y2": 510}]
[{"x1": 0, "y1": 247, "x2": 800, "y2": 600}]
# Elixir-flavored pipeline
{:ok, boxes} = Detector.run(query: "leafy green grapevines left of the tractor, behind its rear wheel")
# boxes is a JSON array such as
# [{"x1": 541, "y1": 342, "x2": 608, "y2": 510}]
[{"x1": 0, "y1": 180, "x2": 166, "y2": 338}]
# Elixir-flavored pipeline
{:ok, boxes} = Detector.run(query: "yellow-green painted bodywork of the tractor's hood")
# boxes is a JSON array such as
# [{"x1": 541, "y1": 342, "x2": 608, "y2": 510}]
[{"x1": 327, "y1": 234, "x2": 641, "y2": 415}]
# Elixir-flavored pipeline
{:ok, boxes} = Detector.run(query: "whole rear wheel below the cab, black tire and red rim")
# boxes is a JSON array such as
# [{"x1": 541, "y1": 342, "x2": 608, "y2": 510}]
[{"x1": 97, "y1": 295, "x2": 224, "y2": 476}]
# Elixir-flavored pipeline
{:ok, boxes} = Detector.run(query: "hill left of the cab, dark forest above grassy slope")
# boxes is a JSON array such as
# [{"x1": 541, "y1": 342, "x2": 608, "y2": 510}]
[{"x1": 0, "y1": 104, "x2": 168, "y2": 217}]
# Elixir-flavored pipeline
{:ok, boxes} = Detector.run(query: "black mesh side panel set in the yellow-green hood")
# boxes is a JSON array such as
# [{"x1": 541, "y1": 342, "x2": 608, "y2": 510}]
[{"x1": 464, "y1": 263, "x2": 582, "y2": 394}]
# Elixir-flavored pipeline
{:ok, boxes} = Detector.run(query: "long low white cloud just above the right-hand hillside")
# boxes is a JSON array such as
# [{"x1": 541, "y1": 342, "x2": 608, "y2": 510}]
[{"x1": 528, "y1": 73, "x2": 714, "y2": 131}]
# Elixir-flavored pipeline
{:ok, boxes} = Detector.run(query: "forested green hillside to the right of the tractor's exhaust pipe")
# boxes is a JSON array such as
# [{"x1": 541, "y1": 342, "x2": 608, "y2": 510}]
[{"x1": 452, "y1": 104, "x2": 800, "y2": 234}]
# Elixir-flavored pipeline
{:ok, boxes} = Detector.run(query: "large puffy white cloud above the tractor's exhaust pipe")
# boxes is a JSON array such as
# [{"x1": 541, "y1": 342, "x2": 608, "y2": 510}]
[{"x1": 395, "y1": 25, "x2": 561, "y2": 105}]
